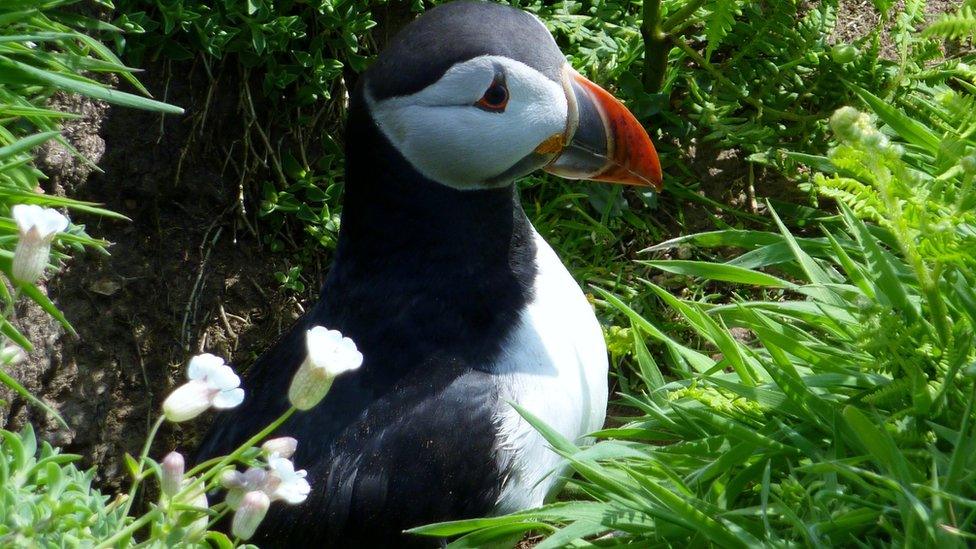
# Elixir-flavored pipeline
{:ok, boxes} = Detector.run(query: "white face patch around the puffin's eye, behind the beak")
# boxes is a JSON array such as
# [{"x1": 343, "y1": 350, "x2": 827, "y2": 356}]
[{"x1": 366, "y1": 55, "x2": 568, "y2": 190}]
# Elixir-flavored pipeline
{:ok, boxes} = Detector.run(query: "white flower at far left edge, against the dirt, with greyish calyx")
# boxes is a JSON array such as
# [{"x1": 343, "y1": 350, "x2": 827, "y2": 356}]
[{"x1": 11, "y1": 204, "x2": 68, "y2": 284}]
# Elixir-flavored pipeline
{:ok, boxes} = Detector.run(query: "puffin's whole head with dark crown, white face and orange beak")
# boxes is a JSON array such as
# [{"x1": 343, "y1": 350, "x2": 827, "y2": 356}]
[{"x1": 363, "y1": 0, "x2": 661, "y2": 190}]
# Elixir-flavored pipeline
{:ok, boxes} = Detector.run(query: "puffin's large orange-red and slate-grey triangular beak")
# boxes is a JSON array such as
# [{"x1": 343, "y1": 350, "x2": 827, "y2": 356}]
[{"x1": 536, "y1": 64, "x2": 661, "y2": 191}]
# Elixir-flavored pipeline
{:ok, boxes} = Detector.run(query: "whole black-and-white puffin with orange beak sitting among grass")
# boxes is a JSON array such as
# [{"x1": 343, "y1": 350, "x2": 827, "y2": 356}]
[{"x1": 195, "y1": 0, "x2": 662, "y2": 547}]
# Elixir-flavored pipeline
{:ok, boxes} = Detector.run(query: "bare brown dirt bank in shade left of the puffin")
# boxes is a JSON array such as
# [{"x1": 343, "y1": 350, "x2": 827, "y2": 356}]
[{"x1": 0, "y1": 1, "x2": 958, "y2": 491}]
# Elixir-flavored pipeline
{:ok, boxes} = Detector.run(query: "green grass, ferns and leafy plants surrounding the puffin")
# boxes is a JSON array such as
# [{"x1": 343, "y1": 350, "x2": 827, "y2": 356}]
[{"x1": 0, "y1": 0, "x2": 976, "y2": 547}]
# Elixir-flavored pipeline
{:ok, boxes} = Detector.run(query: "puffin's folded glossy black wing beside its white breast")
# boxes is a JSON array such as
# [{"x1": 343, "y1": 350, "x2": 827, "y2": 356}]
[{"x1": 257, "y1": 364, "x2": 501, "y2": 547}]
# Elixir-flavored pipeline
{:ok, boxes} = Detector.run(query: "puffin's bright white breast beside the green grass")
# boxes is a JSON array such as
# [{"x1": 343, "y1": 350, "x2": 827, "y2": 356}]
[{"x1": 493, "y1": 227, "x2": 607, "y2": 514}]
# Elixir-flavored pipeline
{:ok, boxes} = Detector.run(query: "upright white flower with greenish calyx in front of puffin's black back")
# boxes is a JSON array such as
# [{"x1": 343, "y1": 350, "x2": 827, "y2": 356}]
[{"x1": 288, "y1": 326, "x2": 363, "y2": 410}]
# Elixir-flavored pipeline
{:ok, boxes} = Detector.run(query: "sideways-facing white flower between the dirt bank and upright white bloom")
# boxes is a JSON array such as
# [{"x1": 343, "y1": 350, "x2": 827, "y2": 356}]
[{"x1": 163, "y1": 354, "x2": 244, "y2": 422}]
